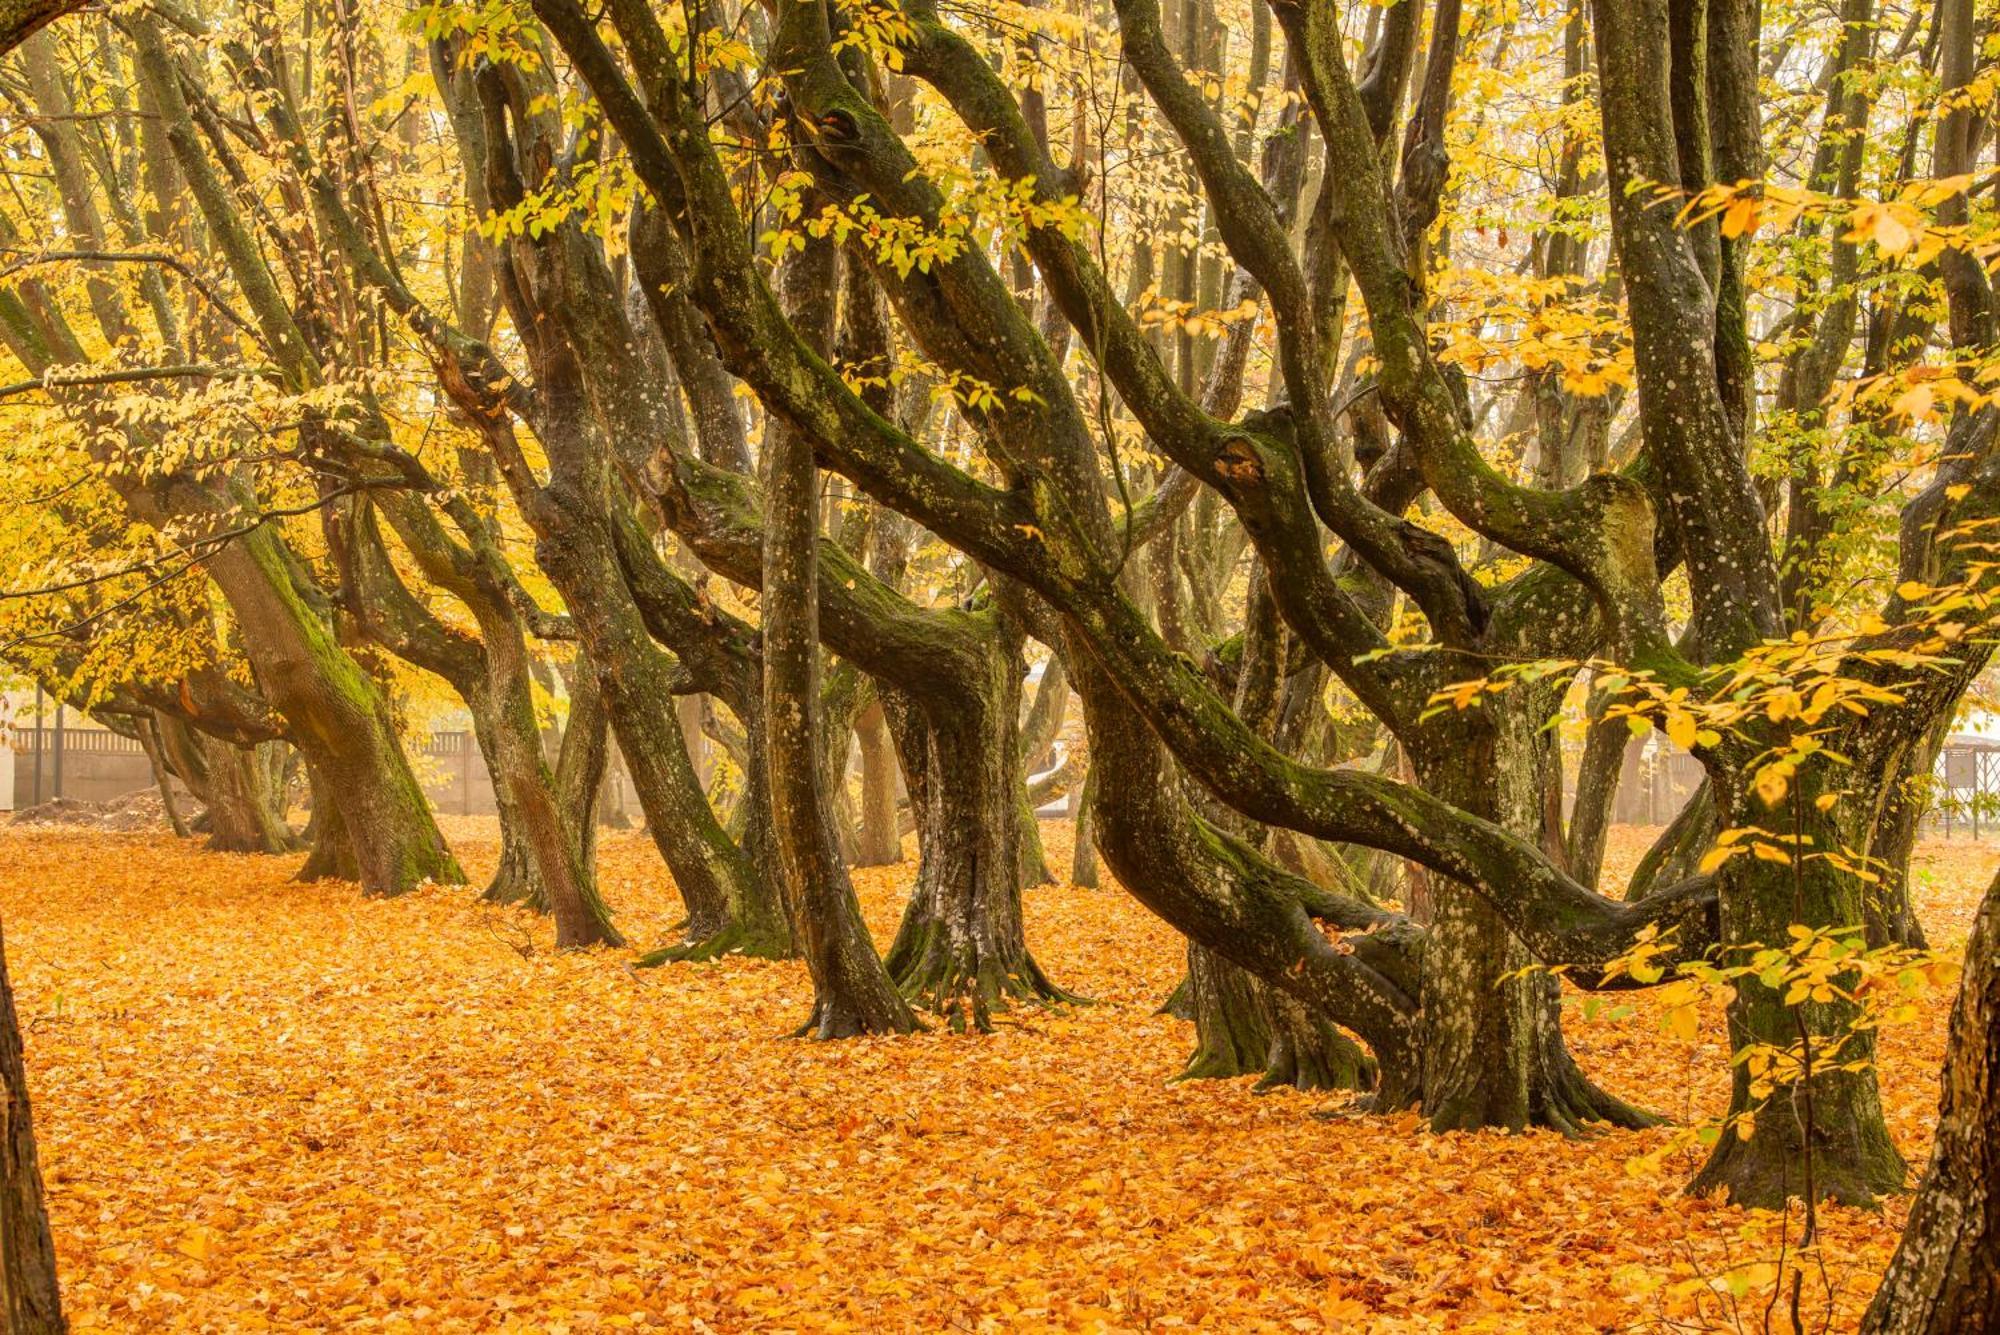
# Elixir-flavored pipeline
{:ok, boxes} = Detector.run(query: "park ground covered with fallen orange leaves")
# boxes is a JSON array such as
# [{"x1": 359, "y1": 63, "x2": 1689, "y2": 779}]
[{"x1": 0, "y1": 821, "x2": 2000, "y2": 1335}]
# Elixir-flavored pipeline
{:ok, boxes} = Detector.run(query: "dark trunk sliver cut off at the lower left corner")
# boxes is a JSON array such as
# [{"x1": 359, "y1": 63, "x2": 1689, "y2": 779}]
[{"x1": 0, "y1": 923, "x2": 68, "y2": 1335}]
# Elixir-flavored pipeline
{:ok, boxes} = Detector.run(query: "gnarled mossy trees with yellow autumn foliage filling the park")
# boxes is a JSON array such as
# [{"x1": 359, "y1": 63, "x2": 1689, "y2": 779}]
[{"x1": 0, "y1": 0, "x2": 2000, "y2": 1331}]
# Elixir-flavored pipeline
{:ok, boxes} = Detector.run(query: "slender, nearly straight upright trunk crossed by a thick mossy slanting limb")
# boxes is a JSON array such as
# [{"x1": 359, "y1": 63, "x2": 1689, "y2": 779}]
[{"x1": 762, "y1": 242, "x2": 916, "y2": 1039}]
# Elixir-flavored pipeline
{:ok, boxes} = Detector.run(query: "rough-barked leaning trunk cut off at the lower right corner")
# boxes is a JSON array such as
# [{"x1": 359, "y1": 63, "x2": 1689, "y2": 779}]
[{"x1": 1862, "y1": 859, "x2": 2000, "y2": 1335}]
